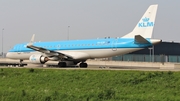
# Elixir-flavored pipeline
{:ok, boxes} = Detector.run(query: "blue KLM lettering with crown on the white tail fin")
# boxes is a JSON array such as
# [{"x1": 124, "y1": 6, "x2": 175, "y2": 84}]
[{"x1": 138, "y1": 17, "x2": 154, "y2": 27}]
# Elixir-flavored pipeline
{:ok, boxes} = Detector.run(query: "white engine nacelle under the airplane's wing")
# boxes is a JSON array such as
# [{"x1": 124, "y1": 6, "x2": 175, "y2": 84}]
[{"x1": 29, "y1": 54, "x2": 49, "y2": 64}]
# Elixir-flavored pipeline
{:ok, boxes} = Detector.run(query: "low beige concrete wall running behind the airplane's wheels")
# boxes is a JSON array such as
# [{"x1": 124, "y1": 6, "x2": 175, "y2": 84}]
[{"x1": 0, "y1": 58, "x2": 180, "y2": 70}]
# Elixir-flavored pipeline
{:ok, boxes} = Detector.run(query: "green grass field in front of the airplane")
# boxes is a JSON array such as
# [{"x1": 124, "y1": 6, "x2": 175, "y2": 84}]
[{"x1": 0, "y1": 68, "x2": 180, "y2": 101}]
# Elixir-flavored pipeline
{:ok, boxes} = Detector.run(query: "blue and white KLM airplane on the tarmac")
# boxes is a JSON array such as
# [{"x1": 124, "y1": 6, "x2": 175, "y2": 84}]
[{"x1": 6, "y1": 4, "x2": 161, "y2": 68}]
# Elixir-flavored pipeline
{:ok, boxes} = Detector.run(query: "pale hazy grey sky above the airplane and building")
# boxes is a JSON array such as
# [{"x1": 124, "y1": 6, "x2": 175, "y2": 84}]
[{"x1": 0, "y1": 0, "x2": 180, "y2": 53}]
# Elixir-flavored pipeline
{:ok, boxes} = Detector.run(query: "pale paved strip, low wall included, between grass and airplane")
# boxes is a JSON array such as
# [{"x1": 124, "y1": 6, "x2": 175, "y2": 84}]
[{"x1": 0, "y1": 58, "x2": 180, "y2": 71}]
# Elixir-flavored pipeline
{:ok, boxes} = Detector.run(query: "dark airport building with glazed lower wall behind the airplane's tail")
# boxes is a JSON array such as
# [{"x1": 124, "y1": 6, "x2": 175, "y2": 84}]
[{"x1": 112, "y1": 42, "x2": 180, "y2": 63}]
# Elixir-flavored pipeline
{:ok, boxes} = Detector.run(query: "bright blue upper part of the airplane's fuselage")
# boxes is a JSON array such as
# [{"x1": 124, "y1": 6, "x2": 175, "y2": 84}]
[{"x1": 9, "y1": 38, "x2": 152, "y2": 52}]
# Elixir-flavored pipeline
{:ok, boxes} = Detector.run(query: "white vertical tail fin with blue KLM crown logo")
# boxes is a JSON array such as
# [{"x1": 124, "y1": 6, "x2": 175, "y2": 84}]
[{"x1": 122, "y1": 4, "x2": 158, "y2": 38}]
